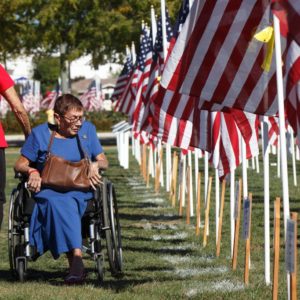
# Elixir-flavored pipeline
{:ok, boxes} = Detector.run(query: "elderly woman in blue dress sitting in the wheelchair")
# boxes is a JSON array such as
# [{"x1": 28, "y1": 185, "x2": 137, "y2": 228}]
[{"x1": 15, "y1": 94, "x2": 108, "y2": 283}]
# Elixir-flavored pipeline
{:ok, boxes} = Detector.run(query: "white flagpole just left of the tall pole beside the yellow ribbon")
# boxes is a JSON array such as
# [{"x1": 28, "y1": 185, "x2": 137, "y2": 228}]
[{"x1": 261, "y1": 117, "x2": 271, "y2": 285}]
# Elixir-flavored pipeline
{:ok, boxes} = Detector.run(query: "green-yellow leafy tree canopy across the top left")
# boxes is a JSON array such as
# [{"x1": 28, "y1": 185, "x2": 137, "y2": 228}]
[{"x1": 0, "y1": 0, "x2": 182, "y2": 76}]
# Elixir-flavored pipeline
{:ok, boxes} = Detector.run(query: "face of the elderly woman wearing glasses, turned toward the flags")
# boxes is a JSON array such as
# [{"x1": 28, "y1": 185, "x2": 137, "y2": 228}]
[{"x1": 57, "y1": 109, "x2": 84, "y2": 136}]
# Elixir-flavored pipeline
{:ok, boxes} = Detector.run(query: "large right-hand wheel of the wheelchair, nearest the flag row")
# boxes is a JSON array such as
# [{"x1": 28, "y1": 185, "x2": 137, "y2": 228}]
[{"x1": 102, "y1": 178, "x2": 121, "y2": 276}]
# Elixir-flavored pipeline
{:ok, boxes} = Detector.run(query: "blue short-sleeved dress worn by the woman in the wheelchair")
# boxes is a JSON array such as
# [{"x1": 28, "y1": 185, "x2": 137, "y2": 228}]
[{"x1": 21, "y1": 122, "x2": 103, "y2": 259}]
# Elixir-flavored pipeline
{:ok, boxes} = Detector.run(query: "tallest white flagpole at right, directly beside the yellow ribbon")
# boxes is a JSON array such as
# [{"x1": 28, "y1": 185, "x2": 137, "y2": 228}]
[{"x1": 273, "y1": 15, "x2": 290, "y2": 232}]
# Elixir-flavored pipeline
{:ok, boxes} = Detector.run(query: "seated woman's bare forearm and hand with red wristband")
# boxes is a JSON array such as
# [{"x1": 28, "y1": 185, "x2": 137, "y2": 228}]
[{"x1": 14, "y1": 155, "x2": 42, "y2": 192}]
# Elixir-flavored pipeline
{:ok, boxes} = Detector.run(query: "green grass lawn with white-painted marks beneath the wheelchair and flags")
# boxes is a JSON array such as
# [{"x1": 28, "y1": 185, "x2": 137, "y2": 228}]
[{"x1": 0, "y1": 147, "x2": 300, "y2": 300}]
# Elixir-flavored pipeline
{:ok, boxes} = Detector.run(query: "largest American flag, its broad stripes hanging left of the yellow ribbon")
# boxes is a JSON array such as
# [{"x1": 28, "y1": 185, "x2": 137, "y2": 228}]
[{"x1": 161, "y1": 0, "x2": 277, "y2": 115}]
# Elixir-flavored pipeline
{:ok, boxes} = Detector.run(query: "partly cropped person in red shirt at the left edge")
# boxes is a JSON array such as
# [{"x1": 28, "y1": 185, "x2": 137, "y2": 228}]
[{"x1": 0, "y1": 65, "x2": 31, "y2": 229}]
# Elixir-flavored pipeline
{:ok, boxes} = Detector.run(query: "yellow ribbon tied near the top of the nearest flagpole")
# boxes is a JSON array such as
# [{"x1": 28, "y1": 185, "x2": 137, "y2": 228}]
[{"x1": 254, "y1": 26, "x2": 275, "y2": 72}]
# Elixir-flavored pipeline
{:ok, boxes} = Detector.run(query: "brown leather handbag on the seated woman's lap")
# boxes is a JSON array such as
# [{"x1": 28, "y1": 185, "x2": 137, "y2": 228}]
[{"x1": 41, "y1": 131, "x2": 91, "y2": 192}]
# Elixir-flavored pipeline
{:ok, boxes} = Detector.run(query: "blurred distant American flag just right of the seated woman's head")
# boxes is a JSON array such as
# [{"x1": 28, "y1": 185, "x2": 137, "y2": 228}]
[{"x1": 80, "y1": 79, "x2": 103, "y2": 111}]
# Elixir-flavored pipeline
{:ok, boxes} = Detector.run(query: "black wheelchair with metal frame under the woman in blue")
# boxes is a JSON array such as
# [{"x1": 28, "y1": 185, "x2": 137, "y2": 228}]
[{"x1": 8, "y1": 174, "x2": 123, "y2": 282}]
